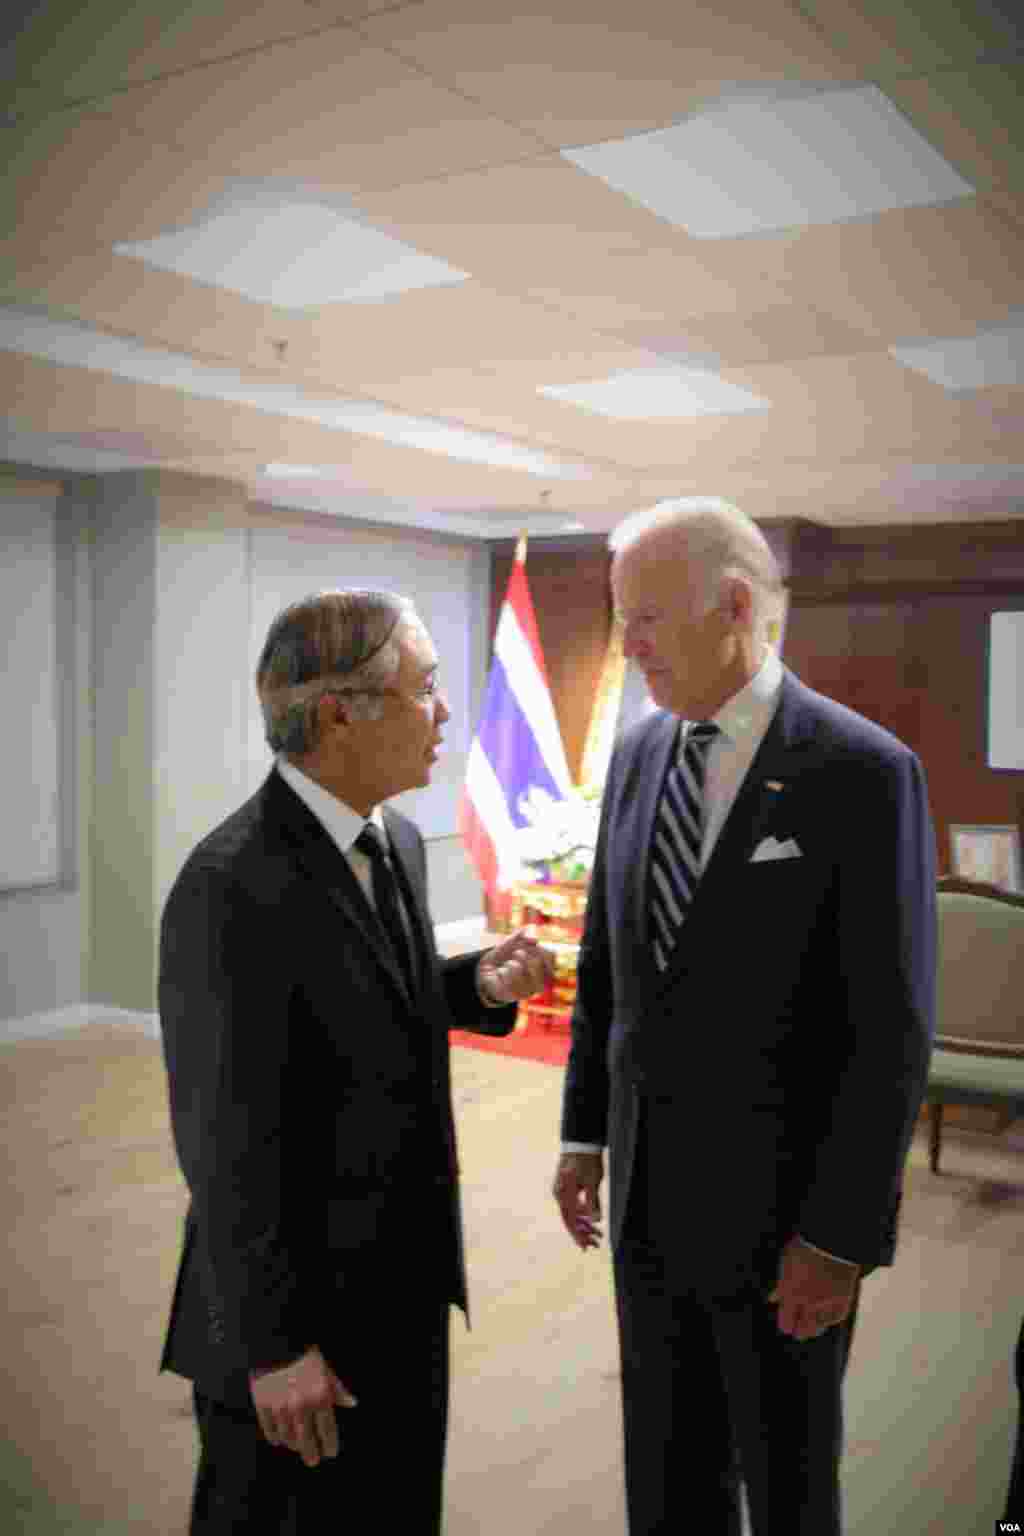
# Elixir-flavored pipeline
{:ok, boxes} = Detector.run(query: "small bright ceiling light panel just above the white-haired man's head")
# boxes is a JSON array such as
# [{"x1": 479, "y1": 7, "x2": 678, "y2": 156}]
[{"x1": 537, "y1": 367, "x2": 769, "y2": 421}]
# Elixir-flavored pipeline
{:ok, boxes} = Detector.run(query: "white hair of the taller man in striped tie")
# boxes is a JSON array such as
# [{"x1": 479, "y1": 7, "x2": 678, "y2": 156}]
[{"x1": 608, "y1": 496, "x2": 785, "y2": 636}]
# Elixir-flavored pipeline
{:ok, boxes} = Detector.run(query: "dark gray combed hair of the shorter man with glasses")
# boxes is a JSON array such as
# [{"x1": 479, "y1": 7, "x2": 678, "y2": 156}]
[{"x1": 256, "y1": 587, "x2": 416, "y2": 756}]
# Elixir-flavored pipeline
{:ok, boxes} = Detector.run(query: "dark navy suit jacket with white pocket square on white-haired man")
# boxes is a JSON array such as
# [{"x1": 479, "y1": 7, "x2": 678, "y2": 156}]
[{"x1": 562, "y1": 671, "x2": 935, "y2": 1293}]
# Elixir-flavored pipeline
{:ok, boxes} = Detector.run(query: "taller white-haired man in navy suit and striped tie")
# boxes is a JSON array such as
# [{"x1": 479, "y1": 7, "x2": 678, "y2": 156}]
[{"x1": 554, "y1": 501, "x2": 935, "y2": 1536}]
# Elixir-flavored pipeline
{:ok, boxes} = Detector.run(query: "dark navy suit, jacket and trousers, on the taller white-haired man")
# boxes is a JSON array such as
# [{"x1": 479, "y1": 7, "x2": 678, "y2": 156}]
[{"x1": 562, "y1": 673, "x2": 935, "y2": 1536}]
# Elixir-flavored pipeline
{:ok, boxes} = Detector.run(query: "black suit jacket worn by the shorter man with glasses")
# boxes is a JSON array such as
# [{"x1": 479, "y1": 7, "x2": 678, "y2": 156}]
[{"x1": 160, "y1": 771, "x2": 516, "y2": 1401}]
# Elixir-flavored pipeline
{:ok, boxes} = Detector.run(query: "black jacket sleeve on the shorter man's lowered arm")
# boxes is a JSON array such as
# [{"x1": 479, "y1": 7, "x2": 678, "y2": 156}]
[{"x1": 160, "y1": 863, "x2": 316, "y2": 1367}]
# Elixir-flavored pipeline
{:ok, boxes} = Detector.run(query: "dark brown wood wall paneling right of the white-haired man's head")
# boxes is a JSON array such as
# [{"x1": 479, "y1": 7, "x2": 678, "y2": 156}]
[{"x1": 761, "y1": 524, "x2": 1024, "y2": 872}]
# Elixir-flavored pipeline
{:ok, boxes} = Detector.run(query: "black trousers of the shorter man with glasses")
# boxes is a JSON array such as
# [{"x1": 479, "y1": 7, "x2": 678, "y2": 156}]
[{"x1": 189, "y1": 1299, "x2": 448, "y2": 1536}]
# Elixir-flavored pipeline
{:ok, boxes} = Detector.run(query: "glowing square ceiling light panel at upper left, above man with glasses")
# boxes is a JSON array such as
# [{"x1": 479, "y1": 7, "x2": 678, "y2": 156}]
[{"x1": 114, "y1": 180, "x2": 468, "y2": 309}]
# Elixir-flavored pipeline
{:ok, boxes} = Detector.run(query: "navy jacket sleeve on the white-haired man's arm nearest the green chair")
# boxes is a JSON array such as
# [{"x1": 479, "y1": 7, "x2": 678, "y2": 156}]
[{"x1": 797, "y1": 737, "x2": 936, "y2": 1267}]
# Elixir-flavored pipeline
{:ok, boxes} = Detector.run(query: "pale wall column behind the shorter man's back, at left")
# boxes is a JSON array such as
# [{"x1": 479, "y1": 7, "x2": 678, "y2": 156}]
[{"x1": 86, "y1": 470, "x2": 249, "y2": 1012}]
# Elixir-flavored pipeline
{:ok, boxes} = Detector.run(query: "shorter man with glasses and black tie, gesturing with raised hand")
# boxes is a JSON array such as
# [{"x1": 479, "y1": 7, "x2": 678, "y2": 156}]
[{"x1": 160, "y1": 590, "x2": 550, "y2": 1536}]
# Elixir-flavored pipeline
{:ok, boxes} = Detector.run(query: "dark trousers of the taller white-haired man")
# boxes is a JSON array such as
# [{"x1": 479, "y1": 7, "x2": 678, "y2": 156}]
[{"x1": 616, "y1": 1124, "x2": 854, "y2": 1536}]
